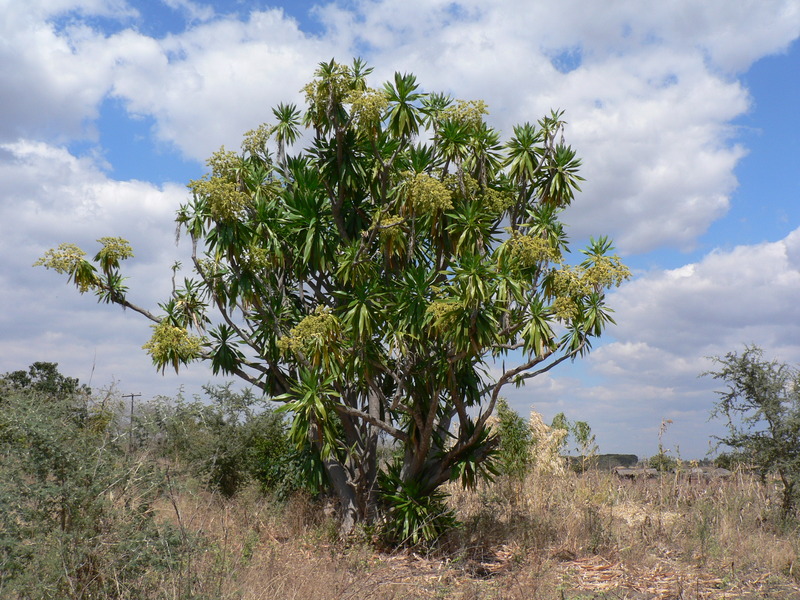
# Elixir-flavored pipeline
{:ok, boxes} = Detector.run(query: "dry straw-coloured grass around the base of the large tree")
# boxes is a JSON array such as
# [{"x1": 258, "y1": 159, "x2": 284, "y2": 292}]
[{"x1": 152, "y1": 473, "x2": 800, "y2": 600}]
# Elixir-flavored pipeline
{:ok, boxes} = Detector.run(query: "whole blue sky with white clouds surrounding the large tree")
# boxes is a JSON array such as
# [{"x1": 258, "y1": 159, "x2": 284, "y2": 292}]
[{"x1": 0, "y1": 0, "x2": 800, "y2": 457}]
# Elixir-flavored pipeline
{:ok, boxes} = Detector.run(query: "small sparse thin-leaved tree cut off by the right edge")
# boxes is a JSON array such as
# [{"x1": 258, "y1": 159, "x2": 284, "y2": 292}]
[{"x1": 703, "y1": 346, "x2": 800, "y2": 514}]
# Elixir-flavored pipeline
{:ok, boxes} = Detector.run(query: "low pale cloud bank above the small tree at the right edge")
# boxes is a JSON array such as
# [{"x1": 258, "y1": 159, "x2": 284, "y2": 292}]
[{"x1": 516, "y1": 229, "x2": 800, "y2": 457}]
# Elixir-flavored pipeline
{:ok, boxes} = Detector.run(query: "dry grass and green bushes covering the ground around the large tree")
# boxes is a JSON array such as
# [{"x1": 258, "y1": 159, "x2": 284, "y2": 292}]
[{"x1": 0, "y1": 363, "x2": 800, "y2": 600}]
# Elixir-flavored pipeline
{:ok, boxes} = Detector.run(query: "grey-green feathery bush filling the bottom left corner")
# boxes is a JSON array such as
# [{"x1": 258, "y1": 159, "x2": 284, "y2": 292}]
[{"x1": 0, "y1": 363, "x2": 187, "y2": 600}]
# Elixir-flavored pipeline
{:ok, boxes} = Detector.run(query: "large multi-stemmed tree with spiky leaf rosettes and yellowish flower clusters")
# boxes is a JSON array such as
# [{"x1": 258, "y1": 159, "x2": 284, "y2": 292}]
[{"x1": 38, "y1": 60, "x2": 629, "y2": 530}]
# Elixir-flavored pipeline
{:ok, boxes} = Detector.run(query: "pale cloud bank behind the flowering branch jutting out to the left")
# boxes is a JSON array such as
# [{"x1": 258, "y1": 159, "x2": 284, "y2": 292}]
[{"x1": 0, "y1": 141, "x2": 220, "y2": 395}]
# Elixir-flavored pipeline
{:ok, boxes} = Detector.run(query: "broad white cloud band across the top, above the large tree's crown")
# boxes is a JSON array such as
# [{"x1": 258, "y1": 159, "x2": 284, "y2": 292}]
[{"x1": 0, "y1": 0, "x2": 800, "y2": 253}]
